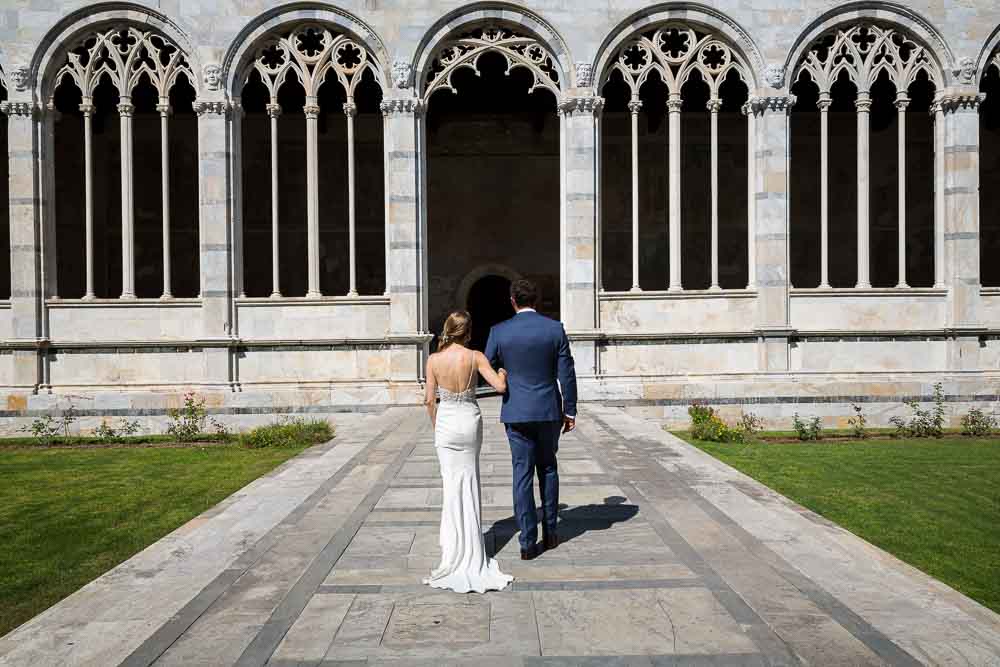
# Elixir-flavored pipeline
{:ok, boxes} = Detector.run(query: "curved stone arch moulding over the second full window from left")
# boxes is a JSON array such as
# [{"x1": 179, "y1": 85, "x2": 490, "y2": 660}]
[{"x1": 222, "y1": 2, "x2": 390, "y2": 97}]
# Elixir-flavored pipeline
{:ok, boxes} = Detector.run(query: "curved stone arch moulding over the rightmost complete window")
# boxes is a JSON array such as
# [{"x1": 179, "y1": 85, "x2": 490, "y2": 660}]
[{"x1": 784, "y1": 0, "x2": 955, "y2": 89}]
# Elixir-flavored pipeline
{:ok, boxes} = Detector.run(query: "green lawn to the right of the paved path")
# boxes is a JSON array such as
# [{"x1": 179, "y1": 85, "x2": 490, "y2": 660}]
[{"x1": 677, "y1": 433, "x2": 1000, "y2": 612}]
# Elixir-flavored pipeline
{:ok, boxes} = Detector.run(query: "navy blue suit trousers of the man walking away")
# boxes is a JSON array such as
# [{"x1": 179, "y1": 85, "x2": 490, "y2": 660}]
[{"x1": 504, "y1": 421, "x2": 562, "y2": 549}]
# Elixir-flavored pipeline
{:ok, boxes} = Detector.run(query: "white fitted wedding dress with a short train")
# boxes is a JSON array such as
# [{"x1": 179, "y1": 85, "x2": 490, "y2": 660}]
[{"x1": 424, "y1": 368, "x2": 514, "y2": 593}]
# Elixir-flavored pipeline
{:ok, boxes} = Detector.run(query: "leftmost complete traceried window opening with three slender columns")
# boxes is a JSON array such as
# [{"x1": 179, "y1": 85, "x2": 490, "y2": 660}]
[{"x1": 48, "y1": 25, "x2": 199, "y2": 299}]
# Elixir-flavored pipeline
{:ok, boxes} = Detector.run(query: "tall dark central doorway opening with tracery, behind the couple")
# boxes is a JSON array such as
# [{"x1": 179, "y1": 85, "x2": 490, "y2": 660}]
[{"x1": 424, "y1": 26, "x2": 561, "y2": 349}]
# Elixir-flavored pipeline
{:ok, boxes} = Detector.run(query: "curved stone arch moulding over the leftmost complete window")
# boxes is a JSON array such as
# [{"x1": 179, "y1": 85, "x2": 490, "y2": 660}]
[{"x1": 29, "y1": 3, "x2": 203, "y2": 100}]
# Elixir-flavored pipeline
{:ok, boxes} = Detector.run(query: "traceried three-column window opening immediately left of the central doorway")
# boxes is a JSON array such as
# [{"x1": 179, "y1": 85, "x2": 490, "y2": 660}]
[{"x1": 240, "y1": 24, "x2": 386, "y2": 298}]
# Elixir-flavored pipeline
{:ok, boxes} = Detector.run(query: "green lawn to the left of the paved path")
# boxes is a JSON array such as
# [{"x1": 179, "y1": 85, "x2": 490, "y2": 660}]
[{"x1": 0, "y1": 441, "x2": 309, "y2": 636}]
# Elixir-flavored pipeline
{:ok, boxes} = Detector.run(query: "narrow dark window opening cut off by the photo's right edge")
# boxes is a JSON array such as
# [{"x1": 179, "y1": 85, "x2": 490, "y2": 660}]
[{"x1": 979, "y1": 49, "x2": 1000, "y2": 287}]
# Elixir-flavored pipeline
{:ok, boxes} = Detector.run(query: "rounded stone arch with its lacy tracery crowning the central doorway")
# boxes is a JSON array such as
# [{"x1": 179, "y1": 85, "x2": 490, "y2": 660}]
[{"x1": 412, "y1": 2, "x2": 572, "y2": 96}]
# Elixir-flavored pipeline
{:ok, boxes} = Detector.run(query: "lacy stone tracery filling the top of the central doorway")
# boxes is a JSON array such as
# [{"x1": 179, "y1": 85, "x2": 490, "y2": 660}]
[{"x1": 424, "y1": 25, "x2": 560, "y2": 99}]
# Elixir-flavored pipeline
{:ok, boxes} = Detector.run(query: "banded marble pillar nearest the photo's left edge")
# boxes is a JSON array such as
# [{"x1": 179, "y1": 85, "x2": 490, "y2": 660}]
[{"x1": 0, "y1": 100, "x2": 44, "y2": 394}]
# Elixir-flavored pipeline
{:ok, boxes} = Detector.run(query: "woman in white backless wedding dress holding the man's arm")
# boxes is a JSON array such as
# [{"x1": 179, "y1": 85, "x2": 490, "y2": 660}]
[{"x1": 424, "y1": 310, "x2": 514, "y2": 593}]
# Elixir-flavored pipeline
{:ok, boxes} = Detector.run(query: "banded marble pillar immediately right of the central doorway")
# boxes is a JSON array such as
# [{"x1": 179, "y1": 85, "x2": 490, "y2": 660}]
[{"x1": 559, "y1": 96, "x2": 604, "y2": 376}]
